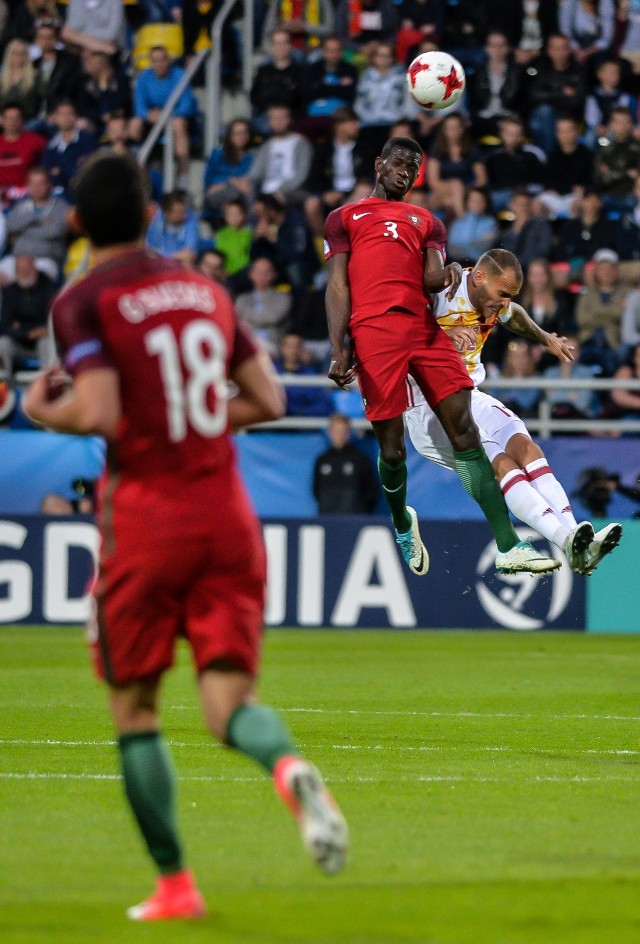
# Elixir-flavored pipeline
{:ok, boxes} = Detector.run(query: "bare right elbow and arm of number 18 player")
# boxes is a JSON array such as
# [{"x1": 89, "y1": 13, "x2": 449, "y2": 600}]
[{"x1": 229, "y1": 351, "x2": 285, "y2": 430}]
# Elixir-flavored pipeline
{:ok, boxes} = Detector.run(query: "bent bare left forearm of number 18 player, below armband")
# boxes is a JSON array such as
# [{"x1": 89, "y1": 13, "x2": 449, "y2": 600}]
[{"x1": 22, "y1": 367, "x2": 121, "y2": 439}]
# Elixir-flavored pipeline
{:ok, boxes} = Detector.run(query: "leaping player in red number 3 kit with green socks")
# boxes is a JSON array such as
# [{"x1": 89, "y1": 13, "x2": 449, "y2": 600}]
[{"x1": 325, "y1": 137, "x2": 559, "y2": 574}]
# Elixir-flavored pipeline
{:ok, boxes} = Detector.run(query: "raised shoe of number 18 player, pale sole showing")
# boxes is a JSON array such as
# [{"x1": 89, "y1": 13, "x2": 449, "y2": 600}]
[{"x1": 276, "y1": 757, "x2": 349, "y2": 875}]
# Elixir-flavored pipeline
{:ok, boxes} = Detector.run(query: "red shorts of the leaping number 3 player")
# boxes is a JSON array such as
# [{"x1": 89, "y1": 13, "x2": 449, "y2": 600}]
[{"x1": 351, "y1": 311, "x2": 473, "y2": 420}]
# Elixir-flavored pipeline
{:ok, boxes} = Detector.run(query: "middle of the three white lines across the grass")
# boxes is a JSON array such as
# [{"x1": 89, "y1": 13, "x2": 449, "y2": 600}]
[{"x1": 0, "y1": 738, "x2": 640, "y2": 756}]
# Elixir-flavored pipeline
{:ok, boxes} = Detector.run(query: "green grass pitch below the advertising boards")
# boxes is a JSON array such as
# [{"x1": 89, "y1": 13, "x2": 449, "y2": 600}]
[{"x1": 0, "y1": 628, "x2": 640, "y2": 944}]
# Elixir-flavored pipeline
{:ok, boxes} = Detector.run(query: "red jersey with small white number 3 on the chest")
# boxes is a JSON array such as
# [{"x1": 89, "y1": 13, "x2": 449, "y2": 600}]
[{"x1": 324, "y1": 197, "x2": 447, "y2": 326}]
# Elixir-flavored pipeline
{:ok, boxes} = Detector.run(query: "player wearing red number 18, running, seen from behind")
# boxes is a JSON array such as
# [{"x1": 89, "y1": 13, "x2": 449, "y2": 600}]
[{"x1": 25, "y1": 153, "x2": 348, "y2": 921}]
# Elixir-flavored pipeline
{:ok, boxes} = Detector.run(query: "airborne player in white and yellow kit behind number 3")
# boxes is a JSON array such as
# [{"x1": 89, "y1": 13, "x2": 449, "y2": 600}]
[{"x1": 405, "y1": 249, "x2": 622, "y2": 574}]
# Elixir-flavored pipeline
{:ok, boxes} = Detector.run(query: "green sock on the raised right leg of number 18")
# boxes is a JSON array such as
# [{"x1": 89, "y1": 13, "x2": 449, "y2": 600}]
[{"x1": 227, "y1": 705, "x2": 298, "y2": 773}]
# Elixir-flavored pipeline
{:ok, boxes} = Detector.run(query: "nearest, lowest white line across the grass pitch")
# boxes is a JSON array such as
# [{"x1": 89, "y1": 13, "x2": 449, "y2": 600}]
[{"x1": 0, "y1": 771, "x2": 640, "y2": 784}]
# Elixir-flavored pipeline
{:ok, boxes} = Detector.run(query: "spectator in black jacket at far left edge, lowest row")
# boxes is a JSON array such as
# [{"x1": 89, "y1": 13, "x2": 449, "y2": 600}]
[{"x1": 0, "y1": 255, "x2": 56, "y2": 376}]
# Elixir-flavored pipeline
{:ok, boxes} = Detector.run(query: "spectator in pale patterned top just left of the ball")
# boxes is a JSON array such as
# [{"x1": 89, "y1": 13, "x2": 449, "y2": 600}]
[{"x1": 354, "y1": 43, "x2": 413, "y2": 165}]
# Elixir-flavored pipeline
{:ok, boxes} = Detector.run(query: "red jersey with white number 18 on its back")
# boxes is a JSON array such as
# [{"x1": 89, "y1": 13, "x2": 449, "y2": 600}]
[{"x1": 53, "y1": 250, "x2": 256, "y2": 507}]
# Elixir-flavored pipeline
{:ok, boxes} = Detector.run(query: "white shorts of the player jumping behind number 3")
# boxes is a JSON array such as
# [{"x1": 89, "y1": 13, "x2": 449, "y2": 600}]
[{"x1": 404, "y1": 387, "x2": 531, "y2": 471}]
